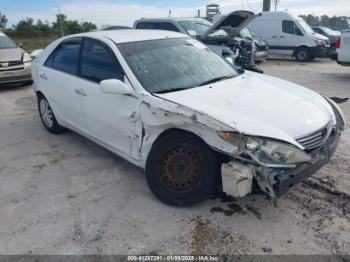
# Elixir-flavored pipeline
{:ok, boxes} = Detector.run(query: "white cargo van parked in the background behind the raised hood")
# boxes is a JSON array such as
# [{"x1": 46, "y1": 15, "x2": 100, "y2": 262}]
[{"x1": 248, "y1": 12, "x2": 330, "y2": 61}]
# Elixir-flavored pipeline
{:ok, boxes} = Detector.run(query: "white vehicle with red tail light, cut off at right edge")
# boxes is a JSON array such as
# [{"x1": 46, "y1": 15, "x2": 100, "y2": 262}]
[{"x1": 332, "y1": 30, "x2": 350, "y2": 66}]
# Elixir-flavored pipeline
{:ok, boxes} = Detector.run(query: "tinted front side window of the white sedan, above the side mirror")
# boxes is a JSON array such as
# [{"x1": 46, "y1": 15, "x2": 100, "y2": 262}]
[{"x1": 80, "y1": 39, "x2": 124, "y2": 83}]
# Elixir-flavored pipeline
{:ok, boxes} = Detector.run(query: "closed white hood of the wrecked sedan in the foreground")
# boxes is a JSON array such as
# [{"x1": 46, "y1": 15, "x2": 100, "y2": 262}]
[{"x1": 157, "y1": 72, "x2": 334, "y2": 147}]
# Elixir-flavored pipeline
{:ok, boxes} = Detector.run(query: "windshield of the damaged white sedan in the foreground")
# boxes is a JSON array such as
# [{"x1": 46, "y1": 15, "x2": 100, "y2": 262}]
[{"x1": 118, "y1": 38, "x2": 238, "y2": 93}]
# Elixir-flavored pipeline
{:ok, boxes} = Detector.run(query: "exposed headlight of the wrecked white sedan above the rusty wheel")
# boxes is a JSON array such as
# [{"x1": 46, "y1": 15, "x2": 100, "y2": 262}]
[{"x1": 218, "y1": 132, "x2": 311, "y2": 165}]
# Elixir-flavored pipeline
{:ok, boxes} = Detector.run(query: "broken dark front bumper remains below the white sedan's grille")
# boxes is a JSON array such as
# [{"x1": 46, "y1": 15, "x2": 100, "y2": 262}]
[{"x1": 270, "y1": 127, "x2": 341, "y2": 197}]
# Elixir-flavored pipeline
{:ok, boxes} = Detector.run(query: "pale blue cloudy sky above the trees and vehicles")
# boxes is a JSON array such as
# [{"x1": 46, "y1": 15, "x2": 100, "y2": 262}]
[{"x1": 0, "y1": 0, "x2": 350, "y2": 27}]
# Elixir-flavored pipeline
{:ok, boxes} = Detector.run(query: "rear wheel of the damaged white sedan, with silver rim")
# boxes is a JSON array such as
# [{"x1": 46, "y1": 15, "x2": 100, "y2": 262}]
[{"x1": 38, "y1": 95, "x2": 65, "y2": 134}]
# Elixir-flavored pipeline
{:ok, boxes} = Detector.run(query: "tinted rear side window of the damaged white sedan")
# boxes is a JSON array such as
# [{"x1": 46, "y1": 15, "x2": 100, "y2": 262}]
[{"x1": 45, "y1": 39, "x2": 81, "y2": 75}]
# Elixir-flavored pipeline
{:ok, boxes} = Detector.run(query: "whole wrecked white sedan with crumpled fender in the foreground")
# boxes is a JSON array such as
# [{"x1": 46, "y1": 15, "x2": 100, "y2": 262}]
[{"x1": 32, "y1": 30, "x2": 345, "y2": 206}]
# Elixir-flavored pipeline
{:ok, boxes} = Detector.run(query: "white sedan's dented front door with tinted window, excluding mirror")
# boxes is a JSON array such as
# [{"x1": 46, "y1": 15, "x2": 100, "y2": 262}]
[{"x1": 79, "y1": 38, "x2": 142, "y2": 159}]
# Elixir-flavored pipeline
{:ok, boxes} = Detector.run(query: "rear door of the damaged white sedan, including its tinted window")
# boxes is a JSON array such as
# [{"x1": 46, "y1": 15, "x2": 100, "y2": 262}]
[{"x1": 37, "y1": 38, "x2": 81, "y2": 127}]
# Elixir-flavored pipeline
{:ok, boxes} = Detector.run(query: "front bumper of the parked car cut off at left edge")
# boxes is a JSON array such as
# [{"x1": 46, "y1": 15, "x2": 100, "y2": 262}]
[{"x1": 0, "y1": 62, "x2": 32, "y2": 84}]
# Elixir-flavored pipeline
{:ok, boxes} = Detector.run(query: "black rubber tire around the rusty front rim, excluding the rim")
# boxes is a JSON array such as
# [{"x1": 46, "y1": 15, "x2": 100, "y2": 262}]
[{"x1": 146, "y1": 133, "x2": 220, "y2": 206}]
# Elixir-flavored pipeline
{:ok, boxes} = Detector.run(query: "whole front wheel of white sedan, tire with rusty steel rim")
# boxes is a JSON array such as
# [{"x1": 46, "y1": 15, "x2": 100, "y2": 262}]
[{"x1": 146, "y1": 132, "x2": 220, "y2": 206}]
